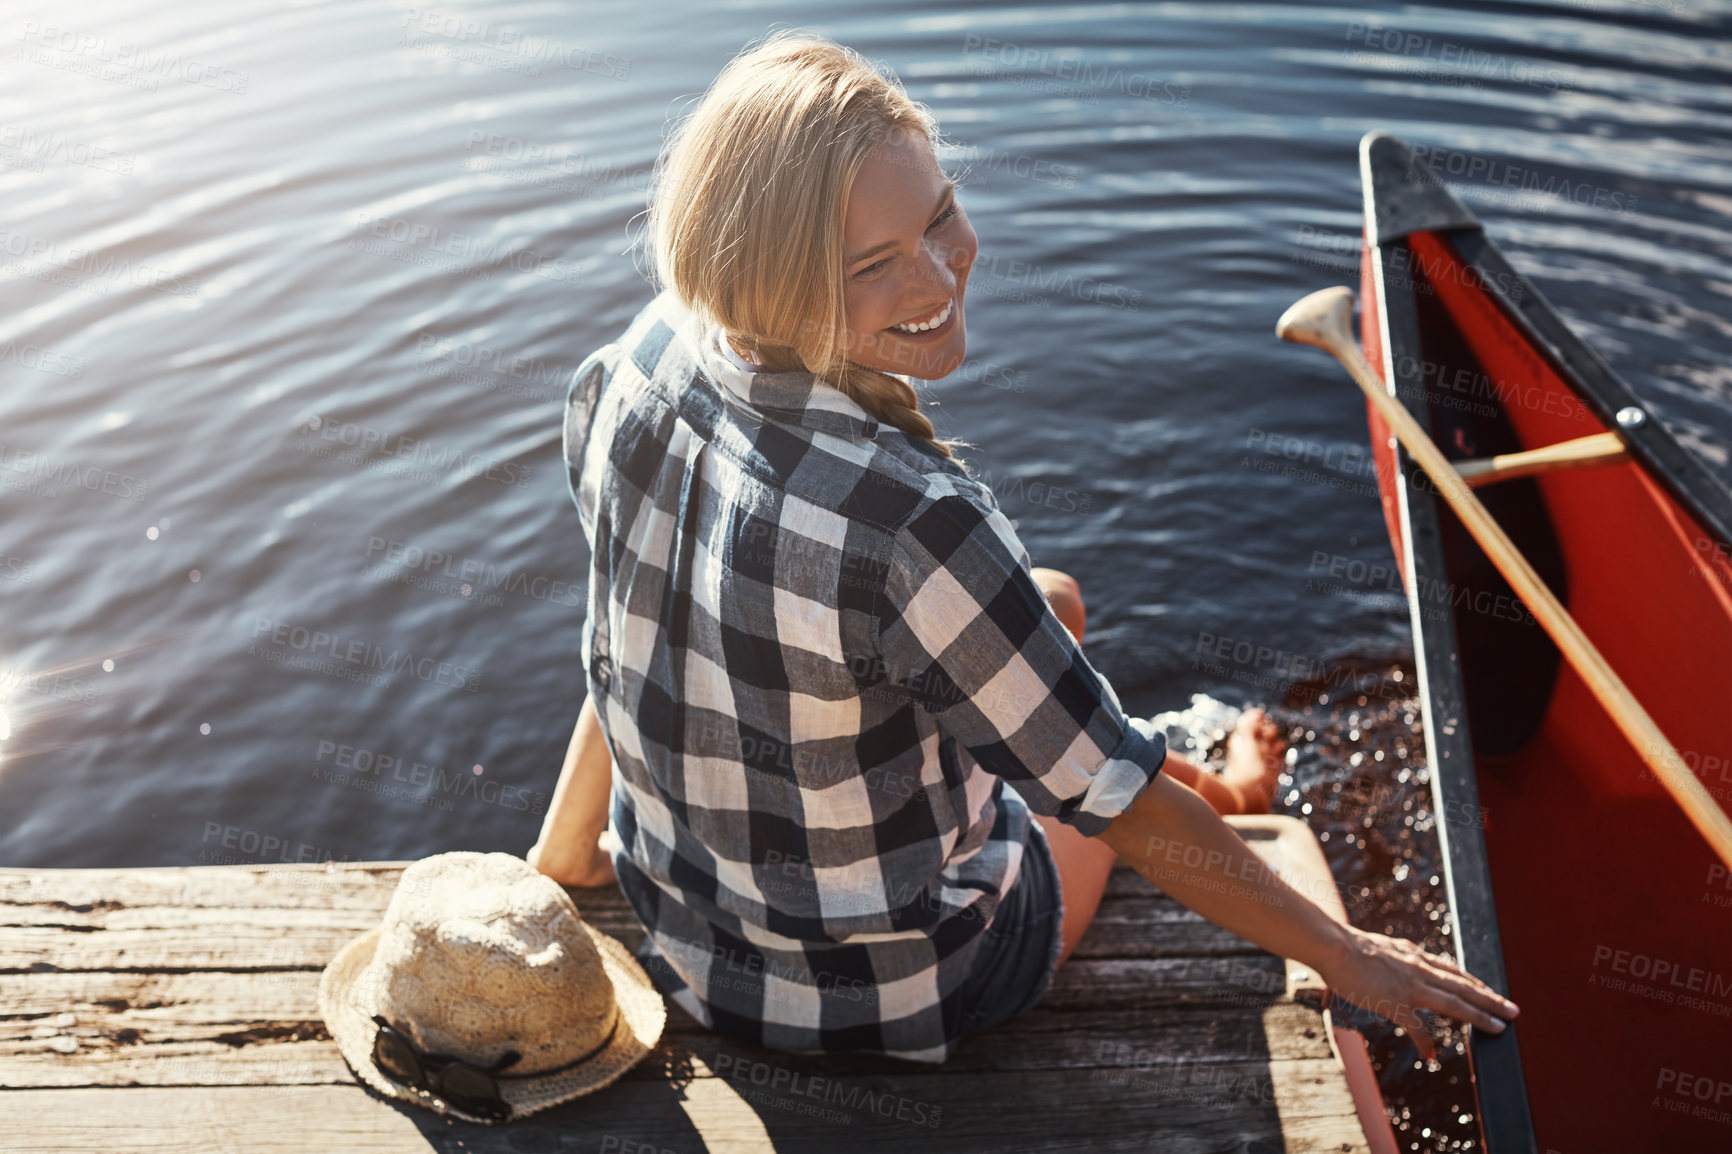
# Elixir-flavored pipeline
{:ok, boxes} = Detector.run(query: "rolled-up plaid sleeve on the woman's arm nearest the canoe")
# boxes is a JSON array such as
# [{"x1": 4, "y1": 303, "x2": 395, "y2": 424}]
[{"x1": 878, "y1": 494, "x2": 1167, "y2": 835}]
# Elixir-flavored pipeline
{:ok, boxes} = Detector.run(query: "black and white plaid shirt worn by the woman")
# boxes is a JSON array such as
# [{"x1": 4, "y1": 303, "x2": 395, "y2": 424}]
[{"x1": 565, "y1": 293, "x2": 1166, "y2": 1062}]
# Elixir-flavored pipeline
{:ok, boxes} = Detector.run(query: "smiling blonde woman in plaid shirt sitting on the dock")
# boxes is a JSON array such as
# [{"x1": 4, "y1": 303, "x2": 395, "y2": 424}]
[{"x1": 530, "y1": 33, "x2": 1516, "y2": 1062}]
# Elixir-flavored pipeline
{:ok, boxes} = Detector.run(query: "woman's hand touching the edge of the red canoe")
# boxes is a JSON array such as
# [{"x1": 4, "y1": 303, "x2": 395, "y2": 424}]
[{"x1": 1318, "y1": 927, "x2": 1521, "y2": 1062}]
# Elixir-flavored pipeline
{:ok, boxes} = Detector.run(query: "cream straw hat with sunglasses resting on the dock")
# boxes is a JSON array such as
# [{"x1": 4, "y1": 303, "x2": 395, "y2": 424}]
[{"x1": 319, "y1": 851, "x2": 667, "y2": 1123}]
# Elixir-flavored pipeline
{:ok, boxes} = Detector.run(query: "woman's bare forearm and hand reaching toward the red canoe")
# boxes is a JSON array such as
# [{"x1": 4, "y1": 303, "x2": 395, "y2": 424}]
[{"x1": 1098, "y1": 773, "x2": 1519, "y2": 1059}]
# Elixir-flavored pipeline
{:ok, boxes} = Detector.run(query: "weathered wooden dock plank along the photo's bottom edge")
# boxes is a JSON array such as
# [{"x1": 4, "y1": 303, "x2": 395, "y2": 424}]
[{"x1": 0, "y1": 1062, "x2": 1367, "y2": 1154}]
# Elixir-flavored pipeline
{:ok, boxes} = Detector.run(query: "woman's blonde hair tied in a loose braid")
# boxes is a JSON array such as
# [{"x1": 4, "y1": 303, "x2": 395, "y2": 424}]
[{"x1": 646, "y1": 29, "x2": 963, "y2": 457}]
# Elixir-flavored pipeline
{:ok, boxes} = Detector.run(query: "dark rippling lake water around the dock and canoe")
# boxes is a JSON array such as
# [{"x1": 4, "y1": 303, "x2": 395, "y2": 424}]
[{"x1": 0, "y1": 0, "x2": 1732, "y2": 1149}]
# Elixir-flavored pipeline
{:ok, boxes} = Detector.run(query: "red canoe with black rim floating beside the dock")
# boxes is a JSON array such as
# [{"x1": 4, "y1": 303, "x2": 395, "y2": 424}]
[{"x1": 1360, "y1": 133, "x2": 1732, "y2": 1154}]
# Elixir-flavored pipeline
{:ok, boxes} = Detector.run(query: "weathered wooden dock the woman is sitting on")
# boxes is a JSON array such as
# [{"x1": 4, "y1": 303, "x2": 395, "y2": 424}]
[{"x1": 0, "y1": 818, "x2": 1394, "y2": 1154}]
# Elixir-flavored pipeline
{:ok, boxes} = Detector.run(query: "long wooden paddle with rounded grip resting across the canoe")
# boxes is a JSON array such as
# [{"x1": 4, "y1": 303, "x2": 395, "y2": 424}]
[{"x1": 1275, "y1": 286, "x2": 1732, "y2": 866}]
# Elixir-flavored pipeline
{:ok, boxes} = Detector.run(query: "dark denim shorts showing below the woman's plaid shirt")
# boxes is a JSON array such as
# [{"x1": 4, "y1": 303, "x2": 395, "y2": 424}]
[{"x1": 961, "y1": 821, "x2": 1065, "y2": 1034}]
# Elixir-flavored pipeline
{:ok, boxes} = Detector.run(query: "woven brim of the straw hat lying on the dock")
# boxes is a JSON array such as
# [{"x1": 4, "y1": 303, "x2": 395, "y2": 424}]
[{"x1": 319, "y1": 922, "x2": 667, "y2": 1123}]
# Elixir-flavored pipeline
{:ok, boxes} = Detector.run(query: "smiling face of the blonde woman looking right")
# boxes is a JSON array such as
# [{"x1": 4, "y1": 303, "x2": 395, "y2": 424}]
[{"x1": 842, "y1": 130, "x2": 980, "y2": 381}]
